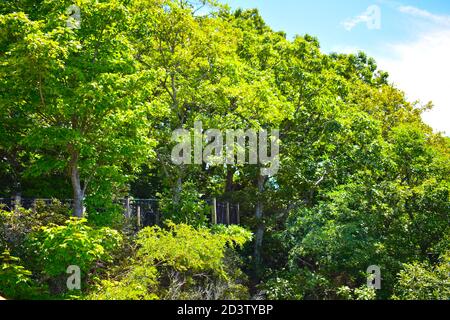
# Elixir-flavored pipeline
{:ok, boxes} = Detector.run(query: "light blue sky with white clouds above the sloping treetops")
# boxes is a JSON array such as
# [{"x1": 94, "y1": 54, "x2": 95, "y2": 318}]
[{"x1": 222, "y1": 0, "x2": 450, "y2": 135}]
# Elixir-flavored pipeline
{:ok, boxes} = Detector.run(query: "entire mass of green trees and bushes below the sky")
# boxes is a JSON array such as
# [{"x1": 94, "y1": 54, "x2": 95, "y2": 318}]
[{"x1": 0, "y1": 0, "x2": 450, "y2": 300}]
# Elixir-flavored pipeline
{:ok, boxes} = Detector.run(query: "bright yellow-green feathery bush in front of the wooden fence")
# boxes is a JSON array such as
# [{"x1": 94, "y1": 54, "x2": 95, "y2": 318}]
[{"x1": 88, "y1": 222, "x2": 251, "y2": 300}]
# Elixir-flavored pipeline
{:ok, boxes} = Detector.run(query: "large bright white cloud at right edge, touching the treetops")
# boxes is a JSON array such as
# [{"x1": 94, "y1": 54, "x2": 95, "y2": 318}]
[{"x1": 377, "y1": 28, "x2": 450, "y2": 135}]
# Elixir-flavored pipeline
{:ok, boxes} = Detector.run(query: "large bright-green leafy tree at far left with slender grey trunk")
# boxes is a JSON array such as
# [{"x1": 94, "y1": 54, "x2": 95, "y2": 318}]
[{"x1": 1, "y1": 1, "x2": 156, "y2": 217}]
